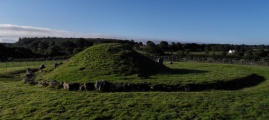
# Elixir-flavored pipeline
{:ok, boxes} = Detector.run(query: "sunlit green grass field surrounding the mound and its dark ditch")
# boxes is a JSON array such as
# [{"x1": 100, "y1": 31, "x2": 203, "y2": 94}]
[{"x1": 0, "y1": 63, "x2": 269, "y2": 120}]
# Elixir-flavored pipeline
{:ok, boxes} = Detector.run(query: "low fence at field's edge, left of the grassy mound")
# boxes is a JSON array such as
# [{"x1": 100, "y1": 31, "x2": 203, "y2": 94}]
[{"x1": 0, "y1": 60, "x2": 63, "y2": 68}]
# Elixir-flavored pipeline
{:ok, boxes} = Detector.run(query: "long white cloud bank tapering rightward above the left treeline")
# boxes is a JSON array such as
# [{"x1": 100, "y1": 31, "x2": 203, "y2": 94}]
[{"x1": 0, "y1": 24, "x2": 118, "y2": 43}]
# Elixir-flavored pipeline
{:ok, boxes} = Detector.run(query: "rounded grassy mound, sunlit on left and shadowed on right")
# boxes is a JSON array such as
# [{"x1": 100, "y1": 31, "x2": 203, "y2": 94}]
[{"x1": 46, "y1": 43, "x2": 169, "y2": 81}]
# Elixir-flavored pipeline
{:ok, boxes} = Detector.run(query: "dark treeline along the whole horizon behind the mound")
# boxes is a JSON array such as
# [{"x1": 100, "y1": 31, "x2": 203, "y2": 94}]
[{"x1": 0, "y1": 37, "x2": 269, "y2": 61}]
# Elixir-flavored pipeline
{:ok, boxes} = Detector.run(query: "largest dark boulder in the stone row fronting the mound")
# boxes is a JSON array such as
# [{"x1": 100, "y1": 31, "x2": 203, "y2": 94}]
[{"x1": 95, "y1": 80, "x2": 116, "y2": 92}]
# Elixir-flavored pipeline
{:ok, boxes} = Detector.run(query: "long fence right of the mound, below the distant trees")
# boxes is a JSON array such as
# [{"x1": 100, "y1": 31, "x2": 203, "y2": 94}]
[{"x1": 150, "y1": 56, "x2": 269, "y2": 66}]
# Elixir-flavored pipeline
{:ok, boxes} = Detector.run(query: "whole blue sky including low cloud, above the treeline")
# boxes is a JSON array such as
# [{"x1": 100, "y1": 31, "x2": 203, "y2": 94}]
[{"x1": 0, "y1": 0, "x2": 269, "y2": 45}]
